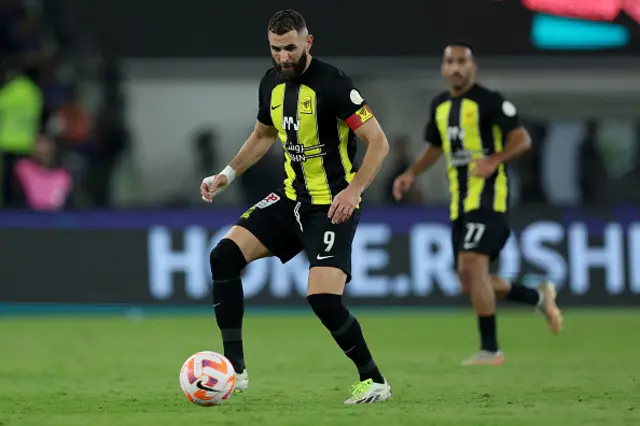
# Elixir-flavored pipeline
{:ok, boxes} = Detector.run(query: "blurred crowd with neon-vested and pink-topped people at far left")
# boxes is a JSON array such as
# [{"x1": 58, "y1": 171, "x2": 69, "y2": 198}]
[{"x1": 0, "y1": 0, "x2": 129, "y2": 210}]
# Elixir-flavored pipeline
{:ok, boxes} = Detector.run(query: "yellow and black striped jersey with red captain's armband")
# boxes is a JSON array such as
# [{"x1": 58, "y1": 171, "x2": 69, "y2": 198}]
[{"x1": 258, "y1": 58, "x2": 373, "y2": 205}]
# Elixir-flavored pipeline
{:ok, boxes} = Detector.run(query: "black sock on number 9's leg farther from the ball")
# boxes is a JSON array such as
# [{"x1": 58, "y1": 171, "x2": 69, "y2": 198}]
[{"x1": 307, "y1": 294, "x2": 384, "y2": 384}]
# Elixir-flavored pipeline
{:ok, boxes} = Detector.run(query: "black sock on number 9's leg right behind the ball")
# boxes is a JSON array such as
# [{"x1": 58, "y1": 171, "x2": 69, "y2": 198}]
[{"x1": 209, "y1": 238, "x2": 247, "y2": 373}]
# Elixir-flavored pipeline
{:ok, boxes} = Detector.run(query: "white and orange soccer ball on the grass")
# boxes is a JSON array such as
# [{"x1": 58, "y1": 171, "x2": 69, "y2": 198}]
[{"x1": 180, "y1": 351, "x2": 236, "y2": 407}]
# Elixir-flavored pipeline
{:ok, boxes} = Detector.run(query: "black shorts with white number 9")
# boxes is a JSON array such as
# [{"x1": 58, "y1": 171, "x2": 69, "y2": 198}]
[{"x1": 236, "y1": 191, "x2": 360, "y2": 282}]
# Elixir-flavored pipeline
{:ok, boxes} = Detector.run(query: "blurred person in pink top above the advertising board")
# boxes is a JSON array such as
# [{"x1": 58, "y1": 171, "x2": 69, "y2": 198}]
[{"x1": 10, "y1": 135, "x2": 72, "y2": 211}]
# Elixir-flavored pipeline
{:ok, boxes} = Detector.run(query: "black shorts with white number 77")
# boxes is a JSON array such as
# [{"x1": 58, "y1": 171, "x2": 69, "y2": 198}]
[{"x1": 451, "y1": 210, "x2": 511, "y2": 269}]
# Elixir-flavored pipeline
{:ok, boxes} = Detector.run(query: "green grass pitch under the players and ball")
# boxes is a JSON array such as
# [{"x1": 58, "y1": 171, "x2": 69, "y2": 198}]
[{"x1": 0, "y1": 310, "x2": 640, "y2": 426}]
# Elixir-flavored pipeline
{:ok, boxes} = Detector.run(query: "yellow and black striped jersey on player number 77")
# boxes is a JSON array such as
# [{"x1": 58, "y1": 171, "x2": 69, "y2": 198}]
[{"x1": 425, "y1": 84, "x2": 520, "y2": 220}]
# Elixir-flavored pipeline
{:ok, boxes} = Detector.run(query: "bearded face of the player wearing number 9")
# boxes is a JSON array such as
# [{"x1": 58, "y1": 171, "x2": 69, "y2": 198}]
[{"x1": 269, "y1": 30, "x2": 313, "y2": 80}]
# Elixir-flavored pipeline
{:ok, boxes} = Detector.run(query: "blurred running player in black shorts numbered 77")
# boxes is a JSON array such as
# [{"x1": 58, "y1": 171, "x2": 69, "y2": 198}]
[{"x1": 393, "y1": 43, "x2": 562, "y2": 365}]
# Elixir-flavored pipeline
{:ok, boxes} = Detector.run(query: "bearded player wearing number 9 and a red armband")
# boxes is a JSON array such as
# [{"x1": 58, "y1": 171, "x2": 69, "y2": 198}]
[{"x1": 200, "y1": 10, "x2": 391, "y2": 404}]
